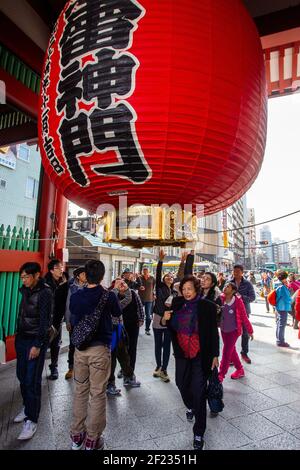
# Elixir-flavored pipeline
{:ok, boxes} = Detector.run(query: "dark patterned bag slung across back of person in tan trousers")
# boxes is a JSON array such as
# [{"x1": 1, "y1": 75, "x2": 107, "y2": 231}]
[{"x1": 71, "y1": 291, "x2": 109, "y2": 351}]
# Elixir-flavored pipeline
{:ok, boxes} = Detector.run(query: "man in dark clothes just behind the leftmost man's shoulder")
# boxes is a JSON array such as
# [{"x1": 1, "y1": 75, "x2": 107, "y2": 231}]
[{"x1": 45, "y1": 259, "x2": 68, "y2": 380}]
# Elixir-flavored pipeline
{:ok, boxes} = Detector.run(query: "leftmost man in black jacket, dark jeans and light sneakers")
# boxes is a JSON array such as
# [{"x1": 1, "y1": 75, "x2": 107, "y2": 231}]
[{"x1": 14, "y1": 262, "x2": 52, "y2": 440}]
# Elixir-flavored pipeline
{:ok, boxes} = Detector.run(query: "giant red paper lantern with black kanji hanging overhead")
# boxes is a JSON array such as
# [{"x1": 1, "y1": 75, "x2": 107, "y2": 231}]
[{"x1": 39, "y1": 0, "x2": 267, "y2": 214}]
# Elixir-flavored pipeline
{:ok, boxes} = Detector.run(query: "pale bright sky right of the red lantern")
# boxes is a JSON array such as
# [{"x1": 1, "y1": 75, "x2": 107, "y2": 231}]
[{"x1": 247, "y1": 93, "x2": 300, "y2": 241}]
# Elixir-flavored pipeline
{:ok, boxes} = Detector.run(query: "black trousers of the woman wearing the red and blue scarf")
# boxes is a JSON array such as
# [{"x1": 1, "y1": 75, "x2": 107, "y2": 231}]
[{"x1": 175, "y1": 355, "x2": 207, "y2": 437}]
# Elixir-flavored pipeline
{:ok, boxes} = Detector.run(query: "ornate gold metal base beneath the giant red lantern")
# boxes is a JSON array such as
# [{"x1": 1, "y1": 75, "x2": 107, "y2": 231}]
[{"x1": 96, "y1": 206, "x2": 197, "y2": 248}]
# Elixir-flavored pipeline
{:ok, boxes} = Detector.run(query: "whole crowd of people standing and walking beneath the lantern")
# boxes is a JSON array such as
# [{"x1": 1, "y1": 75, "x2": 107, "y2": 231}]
[{"x1": 14, "y1": 255, "x2": 300, "y2": 450}]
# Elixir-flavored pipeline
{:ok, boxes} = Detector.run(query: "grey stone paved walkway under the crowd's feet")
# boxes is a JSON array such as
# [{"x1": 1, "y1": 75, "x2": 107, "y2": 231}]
[{"x1": 0, "y1": 301, "x2": 300, "y2": 450}]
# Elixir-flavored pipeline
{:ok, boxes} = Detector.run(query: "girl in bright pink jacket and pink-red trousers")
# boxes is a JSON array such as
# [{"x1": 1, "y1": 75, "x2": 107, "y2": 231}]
[{"x1": 219, "y1": 282, "x2": 253, "y2": 382}]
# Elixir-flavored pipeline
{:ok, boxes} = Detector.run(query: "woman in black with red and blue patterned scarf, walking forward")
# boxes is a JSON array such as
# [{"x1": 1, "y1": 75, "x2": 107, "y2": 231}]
[{"x1": 161, "y1": 276, "x2": 219, "y2": 450}]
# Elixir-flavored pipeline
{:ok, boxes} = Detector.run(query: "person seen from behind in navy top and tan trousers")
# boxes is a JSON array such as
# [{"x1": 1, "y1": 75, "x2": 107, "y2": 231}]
[{"x1": 70, "y1": 260, "x2": 122, "y2": 450}]
